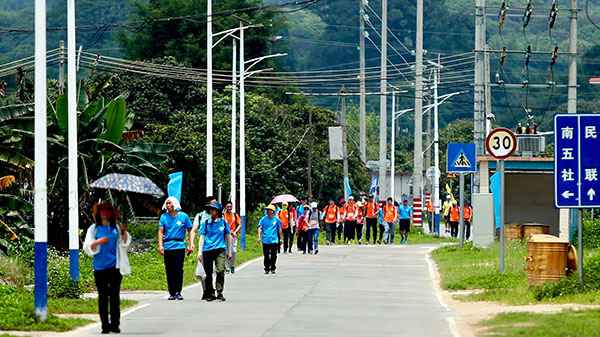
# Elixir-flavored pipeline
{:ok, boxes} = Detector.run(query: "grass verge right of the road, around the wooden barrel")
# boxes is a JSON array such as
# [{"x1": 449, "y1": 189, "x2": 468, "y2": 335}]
[{"x1": 432, "y1": 241, "x2": 600, "y2": 305}]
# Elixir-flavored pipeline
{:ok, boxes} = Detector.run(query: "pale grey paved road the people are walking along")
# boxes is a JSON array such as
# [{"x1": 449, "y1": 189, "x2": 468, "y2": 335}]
[{"x1": 71, "y1": 246, "x2": 452, "y2": 337}]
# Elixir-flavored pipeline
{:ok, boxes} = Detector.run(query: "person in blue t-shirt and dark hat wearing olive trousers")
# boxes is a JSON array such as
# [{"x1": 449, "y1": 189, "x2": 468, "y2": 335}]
[{"x1": 198, "y1": 201, "x2": 233, "y2": 302}]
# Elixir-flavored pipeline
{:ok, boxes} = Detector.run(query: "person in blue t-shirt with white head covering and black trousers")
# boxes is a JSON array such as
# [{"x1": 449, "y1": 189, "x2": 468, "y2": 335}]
[{"x1": 158, "y1": 197, "x2": 194, "y2": 301}]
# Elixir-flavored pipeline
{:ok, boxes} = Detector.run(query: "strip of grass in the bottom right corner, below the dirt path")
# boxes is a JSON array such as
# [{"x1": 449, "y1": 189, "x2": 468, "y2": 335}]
[{"x1": 481, "y1": 310, "x2": 600, "y2": 337}]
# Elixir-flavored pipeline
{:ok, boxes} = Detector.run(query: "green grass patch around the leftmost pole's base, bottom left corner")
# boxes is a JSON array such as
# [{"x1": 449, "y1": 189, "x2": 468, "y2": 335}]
[{"x1": 0, "y1": 286, "x2": 92, "y2": 331}]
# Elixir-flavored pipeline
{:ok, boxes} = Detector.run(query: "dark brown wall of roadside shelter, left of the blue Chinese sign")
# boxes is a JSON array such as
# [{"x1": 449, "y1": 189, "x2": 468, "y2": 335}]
[{"x1": 505, "y1": 172, "x2": 559, "y2": 235}]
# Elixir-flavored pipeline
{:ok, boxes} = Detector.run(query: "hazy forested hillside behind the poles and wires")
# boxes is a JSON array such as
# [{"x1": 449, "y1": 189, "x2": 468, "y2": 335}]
[{"x1": 0, "y1": 0, "x2": 600, "y2": 131}]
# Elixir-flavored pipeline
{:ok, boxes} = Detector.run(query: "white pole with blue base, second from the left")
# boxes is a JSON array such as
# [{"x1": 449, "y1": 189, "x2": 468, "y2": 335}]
[{"x1": 63, "y1": 0, "x2": 79, "y2": 282}]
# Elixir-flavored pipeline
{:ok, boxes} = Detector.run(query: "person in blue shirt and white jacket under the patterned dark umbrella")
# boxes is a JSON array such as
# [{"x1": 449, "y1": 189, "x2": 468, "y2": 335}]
[{"x1": 83, "y1": 203, "x2": 131, "y2": 334}]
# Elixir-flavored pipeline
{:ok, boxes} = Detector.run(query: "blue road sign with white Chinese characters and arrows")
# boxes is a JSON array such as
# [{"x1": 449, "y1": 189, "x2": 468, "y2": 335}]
[{"x1": 554, "y1": 114, "x2": 600, "y2": 208}]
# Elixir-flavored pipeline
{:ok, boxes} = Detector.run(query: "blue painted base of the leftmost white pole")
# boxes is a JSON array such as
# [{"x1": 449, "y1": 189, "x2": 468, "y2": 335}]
[{"x1": 34, "y1": 242, "x2": 48, "y2": 322}]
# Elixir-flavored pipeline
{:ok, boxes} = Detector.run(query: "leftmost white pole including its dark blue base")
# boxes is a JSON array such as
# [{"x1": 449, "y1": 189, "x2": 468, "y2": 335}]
[{"x1": 33, "y1": 0, "x2": 48, "y2": 321}]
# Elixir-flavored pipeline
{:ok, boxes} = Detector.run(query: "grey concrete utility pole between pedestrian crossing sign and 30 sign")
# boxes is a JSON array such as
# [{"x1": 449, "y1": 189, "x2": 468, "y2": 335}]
[{"x1": 473, "y1": 0, "x2": 486, "y2": 193}]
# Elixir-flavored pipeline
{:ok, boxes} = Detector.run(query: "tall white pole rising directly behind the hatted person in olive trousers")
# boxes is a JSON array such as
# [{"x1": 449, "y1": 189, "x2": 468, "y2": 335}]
[{"x1": 206, "y1": 0, "x2": 213, "y2": 196}]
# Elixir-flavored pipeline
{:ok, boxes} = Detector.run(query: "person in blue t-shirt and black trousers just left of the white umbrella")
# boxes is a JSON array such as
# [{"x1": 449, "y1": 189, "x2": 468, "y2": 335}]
[{"x1": 258, "y1": 205, "x2": 283, "y2": 274}]
